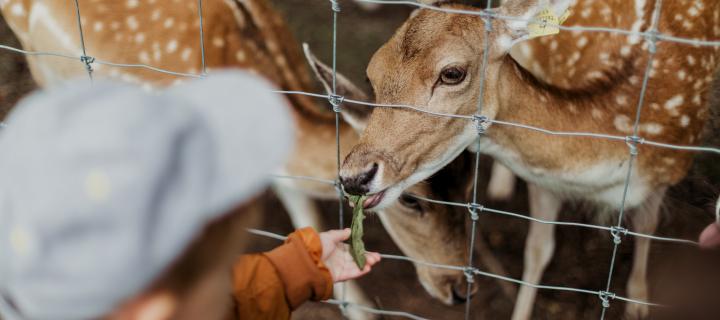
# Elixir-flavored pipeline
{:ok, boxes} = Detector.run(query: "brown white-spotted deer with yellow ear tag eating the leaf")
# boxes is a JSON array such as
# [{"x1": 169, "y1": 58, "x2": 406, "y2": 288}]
[{"x1": 334, "y1": 0, "x2": 720, "y2": 319}]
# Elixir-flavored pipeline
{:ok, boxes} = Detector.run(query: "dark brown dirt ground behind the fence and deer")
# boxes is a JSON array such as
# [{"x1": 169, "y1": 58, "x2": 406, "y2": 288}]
[{"x1": 0, "y1": 0, "x2": 720, "y2": 319}]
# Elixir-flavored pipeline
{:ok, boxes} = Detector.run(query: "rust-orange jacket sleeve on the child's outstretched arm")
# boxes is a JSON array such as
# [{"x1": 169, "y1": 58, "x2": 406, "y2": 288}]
[{"x1": 233, "y1": 227, "x2": 333, "y2": 319}]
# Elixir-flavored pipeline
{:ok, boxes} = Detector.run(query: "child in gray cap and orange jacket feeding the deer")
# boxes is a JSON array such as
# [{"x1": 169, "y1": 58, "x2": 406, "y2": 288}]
[{"x1": 0, "y1": 72, "x2": 380, "y2": 320}]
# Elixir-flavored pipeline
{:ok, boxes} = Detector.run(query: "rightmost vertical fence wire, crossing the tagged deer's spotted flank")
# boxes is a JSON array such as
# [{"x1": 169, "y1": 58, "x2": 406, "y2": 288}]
[{"x1": 600, "y1": 0, "x2": 662, "y2": 320}]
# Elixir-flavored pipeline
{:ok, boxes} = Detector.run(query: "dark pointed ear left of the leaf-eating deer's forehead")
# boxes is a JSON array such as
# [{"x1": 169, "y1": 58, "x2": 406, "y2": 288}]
[{"x1": 303, "y1": 43, "x2": 373, "y2": 132}]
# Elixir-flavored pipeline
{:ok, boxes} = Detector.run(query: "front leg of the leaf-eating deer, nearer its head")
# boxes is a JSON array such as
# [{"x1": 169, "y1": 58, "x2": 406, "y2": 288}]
[{"x1": 512, "y1": 184, "x2": 562, "y2": 320}]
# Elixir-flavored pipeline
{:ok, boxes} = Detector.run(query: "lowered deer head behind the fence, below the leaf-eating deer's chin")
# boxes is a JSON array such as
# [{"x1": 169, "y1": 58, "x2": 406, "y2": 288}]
[{"x1": 378, "y1": 154, "x2": 478, "y2": 304}]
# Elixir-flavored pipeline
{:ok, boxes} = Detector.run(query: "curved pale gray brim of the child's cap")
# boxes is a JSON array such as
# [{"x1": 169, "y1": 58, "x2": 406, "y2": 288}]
[{"x1": 165, "y1": 71, "x2": 294, "y2": 215}]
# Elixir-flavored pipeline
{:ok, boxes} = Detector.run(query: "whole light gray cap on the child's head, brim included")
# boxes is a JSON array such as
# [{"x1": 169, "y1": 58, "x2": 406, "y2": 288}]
[{"x1": 0, "y1": 72, "x2": 294, "y2": 319}]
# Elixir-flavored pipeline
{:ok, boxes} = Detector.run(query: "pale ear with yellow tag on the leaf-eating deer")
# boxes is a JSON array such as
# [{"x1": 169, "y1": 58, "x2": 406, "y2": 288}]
[{"x1": 496, "y1": 0, "x2": 575, "y2": 51}]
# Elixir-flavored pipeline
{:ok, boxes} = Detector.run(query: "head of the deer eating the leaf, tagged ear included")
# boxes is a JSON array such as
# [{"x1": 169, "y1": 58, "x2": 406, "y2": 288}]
[{"x1": 340, "y1": 0, "x2": 572, "y2": 208}]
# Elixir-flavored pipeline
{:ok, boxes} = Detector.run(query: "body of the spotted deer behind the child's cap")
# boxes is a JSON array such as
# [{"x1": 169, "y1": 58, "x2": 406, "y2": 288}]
[{"x1": 1, "y1": 0, "x2": 372, "y2": 319}]
